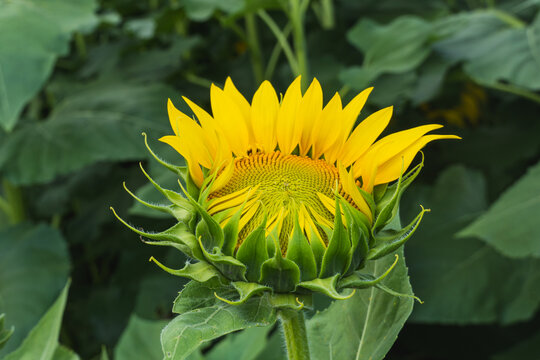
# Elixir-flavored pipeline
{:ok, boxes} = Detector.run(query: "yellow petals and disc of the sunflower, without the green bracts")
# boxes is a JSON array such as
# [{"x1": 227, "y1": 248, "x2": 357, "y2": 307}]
[{"x1": 160, "y1": 77, "x2": 458, "y2": 254}]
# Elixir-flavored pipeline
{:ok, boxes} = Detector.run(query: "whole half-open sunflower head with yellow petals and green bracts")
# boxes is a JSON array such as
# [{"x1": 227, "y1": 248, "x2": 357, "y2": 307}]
[{"x1": 115, "y1": 78, "x2": 457, "y2": 303}]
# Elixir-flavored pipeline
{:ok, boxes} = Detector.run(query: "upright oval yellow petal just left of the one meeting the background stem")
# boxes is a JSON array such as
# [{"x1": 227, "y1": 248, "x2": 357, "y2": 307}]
[{"x1": 251, "y1": 81, "x2": 279, "y2": 153}]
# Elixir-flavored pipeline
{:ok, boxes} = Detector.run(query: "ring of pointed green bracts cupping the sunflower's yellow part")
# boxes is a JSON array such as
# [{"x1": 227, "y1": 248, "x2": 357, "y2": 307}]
[{"x1": 113, "y1": 135, "x2": 428, "y2": 309}]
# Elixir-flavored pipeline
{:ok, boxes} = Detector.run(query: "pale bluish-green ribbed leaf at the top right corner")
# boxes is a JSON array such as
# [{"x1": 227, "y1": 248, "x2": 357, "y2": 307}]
[{"x1": 434, "y1": 10, "x2": 540, "y2": 90}]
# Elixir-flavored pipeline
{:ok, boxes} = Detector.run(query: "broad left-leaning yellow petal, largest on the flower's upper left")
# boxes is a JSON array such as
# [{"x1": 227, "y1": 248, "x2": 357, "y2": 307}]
[{"x1": 210, "y1": 84, "x2": 249, "y2": 156}]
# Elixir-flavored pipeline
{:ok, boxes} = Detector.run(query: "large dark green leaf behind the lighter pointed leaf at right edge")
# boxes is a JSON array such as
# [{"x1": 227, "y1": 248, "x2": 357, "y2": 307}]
[{"x1": 402, "y1": 166, "x2": 540, "y2": 324}]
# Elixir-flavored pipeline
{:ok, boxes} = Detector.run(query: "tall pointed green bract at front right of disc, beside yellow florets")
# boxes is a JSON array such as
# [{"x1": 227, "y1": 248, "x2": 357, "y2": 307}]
[{"x1": 319, "y1": 197, "x2": 351, "y2": 278}]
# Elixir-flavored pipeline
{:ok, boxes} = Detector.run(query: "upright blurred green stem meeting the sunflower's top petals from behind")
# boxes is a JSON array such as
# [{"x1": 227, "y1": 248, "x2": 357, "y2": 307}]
[{"x1": 289, "y1": 0, "x2": 309, "y2": 88}]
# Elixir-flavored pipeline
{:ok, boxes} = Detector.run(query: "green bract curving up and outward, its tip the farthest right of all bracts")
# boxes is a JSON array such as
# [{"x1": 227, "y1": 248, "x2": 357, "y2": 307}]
[{"x1": 367, "y1": 207, "x2": 429, "y2": 260}]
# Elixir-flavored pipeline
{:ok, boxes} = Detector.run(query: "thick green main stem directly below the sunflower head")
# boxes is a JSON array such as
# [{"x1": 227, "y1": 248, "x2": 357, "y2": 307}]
[{"x1": 278, "y1": 309, "x2": 310, "y2": 360}]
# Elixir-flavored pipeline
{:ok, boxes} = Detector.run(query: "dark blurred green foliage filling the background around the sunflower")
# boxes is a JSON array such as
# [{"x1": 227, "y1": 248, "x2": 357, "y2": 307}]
[{"x1": 0, "y1": 0, "x2": 540, "y2": 360}]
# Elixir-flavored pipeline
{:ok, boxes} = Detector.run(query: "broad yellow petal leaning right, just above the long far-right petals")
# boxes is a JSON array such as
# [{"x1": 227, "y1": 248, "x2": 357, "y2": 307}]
[{"x1": 339, "y1": 106, "x2": 393, "y2": 167}]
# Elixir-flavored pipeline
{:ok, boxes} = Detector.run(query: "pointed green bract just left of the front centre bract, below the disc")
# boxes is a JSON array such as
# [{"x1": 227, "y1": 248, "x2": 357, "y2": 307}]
[{"x1": 236, "y1": 217, "x2": 269, "y2": 282}]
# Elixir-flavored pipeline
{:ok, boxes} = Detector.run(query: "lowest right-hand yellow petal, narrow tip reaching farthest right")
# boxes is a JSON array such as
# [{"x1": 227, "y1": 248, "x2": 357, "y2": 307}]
[{"x1": 374, "y1": 135, "x2": 460, "y2": 185}]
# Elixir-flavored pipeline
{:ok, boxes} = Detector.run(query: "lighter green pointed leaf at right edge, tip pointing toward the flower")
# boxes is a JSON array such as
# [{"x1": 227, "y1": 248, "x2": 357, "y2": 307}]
[{"x1": 458, "y1": 163, "x2": 540, "y2": 257}]
